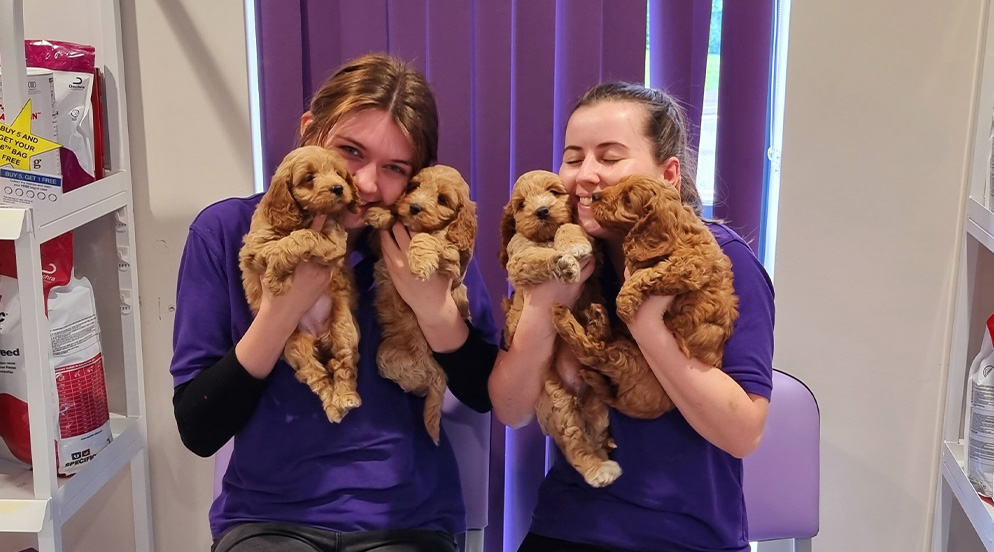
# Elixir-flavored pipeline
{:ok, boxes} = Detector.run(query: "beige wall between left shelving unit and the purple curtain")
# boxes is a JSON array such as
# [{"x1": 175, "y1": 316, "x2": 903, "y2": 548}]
[{"x1": 0, "y1": 0, "x2": 252, "y2": 552}]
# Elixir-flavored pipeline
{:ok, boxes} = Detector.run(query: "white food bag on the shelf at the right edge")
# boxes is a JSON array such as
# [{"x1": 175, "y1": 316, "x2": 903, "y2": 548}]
[{"x1": 966, "y1": 315, "x2": 994, "y2": 497}]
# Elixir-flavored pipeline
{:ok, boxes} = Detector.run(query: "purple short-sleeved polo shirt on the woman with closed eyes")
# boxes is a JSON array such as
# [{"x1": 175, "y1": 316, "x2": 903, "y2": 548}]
[{"x1": 531, "y1": 223, "x2": 773, "y2": 552}]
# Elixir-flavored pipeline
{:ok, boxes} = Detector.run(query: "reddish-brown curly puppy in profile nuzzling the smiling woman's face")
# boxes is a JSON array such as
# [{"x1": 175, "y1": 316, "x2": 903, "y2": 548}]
[{"x1": 591, "y1": 175, "x2": 738, "y2": 368}]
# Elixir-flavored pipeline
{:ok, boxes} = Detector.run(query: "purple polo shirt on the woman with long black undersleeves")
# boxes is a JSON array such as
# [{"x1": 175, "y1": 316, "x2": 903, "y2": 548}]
[{"x1": 170, "y1": 194, "x2": 498, "y2": 539}]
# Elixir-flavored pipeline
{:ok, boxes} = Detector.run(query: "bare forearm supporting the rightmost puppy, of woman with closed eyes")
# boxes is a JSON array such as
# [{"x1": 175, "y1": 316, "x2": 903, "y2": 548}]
[{"x1": 631, "y1": 318, "x2": 769, "y2": 458}]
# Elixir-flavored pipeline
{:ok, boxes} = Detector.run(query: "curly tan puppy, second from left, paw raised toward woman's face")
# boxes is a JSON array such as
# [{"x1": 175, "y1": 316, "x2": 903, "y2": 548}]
[{"x1": 366, "y1": 165, "x2": 476, "y2": 444}]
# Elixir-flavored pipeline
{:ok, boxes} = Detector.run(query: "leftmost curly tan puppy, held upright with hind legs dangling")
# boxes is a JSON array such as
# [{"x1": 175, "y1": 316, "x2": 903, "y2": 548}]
[{"x1": 239, "y1": 146, "x2": 361, "y2": 422}]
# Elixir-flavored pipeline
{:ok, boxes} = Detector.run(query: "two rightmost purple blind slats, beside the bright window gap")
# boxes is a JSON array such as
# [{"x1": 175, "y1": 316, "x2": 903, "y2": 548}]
[{"x1": 649, "y1": 0, "x2": 775, "y2": 252}]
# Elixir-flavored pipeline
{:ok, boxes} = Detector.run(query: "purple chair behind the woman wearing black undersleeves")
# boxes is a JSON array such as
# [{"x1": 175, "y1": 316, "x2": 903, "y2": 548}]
[{"x1": 214, "y1": 391, "x2": 490, "y2": 552}]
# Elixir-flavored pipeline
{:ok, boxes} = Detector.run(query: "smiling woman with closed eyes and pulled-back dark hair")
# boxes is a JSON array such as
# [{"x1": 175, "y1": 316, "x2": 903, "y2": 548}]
[{"x1": 490, "y1": 82, "x2": 773, "y2": 552}]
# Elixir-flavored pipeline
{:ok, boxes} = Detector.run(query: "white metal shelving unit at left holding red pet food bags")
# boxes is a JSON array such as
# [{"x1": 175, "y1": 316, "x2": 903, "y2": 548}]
[{"x1": 0, "y1": 0, "x2": 153, "y2": 552}]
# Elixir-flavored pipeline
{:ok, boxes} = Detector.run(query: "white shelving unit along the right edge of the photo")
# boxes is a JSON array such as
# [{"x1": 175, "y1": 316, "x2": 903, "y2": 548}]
[{"x1": 932, "y1": 2, "x2": 994, "y2": 552}]
